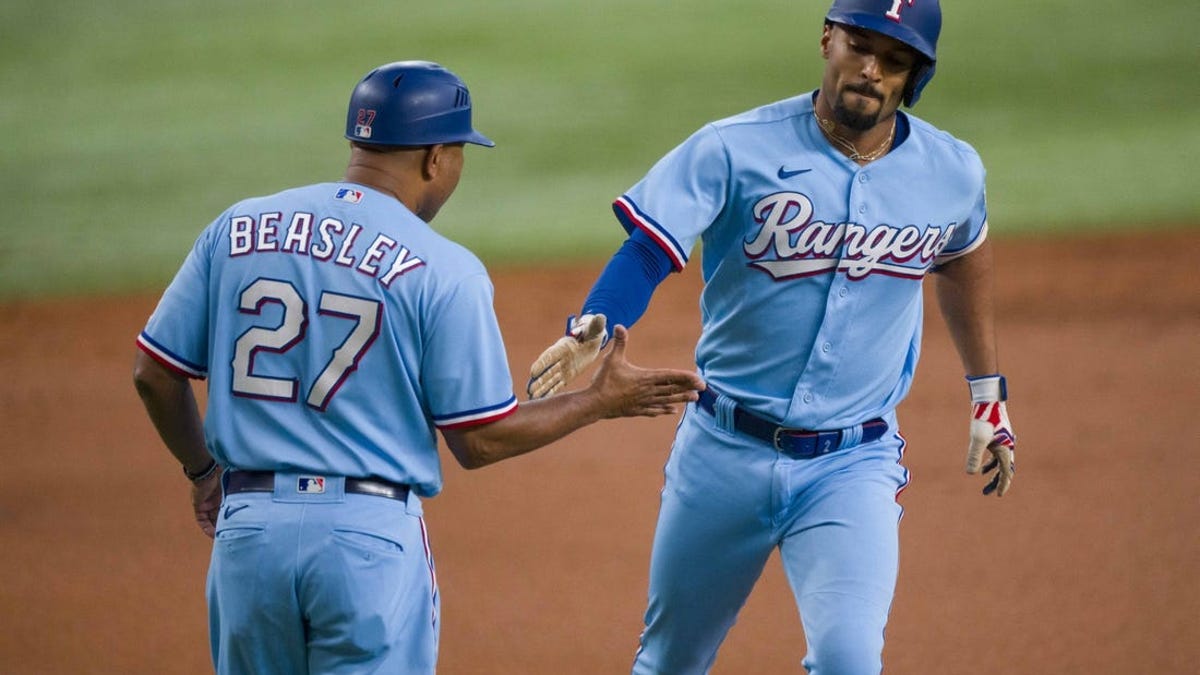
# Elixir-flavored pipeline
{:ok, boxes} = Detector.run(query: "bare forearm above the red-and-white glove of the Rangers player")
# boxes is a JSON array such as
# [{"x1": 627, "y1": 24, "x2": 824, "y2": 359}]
[{"x1": 935, "y1": 241, "x2": 1000, "y2": 376}]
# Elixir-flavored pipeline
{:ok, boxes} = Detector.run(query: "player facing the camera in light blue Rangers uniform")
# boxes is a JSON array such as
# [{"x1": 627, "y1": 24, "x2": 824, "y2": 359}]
[{"x1": 528, "y1": 0, "x2": 1014, "y2": 675}]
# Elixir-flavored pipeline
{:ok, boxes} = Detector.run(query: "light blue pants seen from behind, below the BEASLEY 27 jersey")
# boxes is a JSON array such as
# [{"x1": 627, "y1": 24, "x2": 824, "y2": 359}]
[{"x1": 208, "y1": 474, "x2": 439, "y2": 675}]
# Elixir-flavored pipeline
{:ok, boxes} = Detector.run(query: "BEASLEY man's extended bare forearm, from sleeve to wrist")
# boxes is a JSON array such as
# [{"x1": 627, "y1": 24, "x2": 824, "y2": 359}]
[{"x1": 442, "y1": 390, "x2": 604, "y2": 468}]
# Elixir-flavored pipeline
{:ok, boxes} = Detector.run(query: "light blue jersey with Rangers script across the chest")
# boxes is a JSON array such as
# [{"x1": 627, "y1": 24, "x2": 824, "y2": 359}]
[{"x1": 616, "y1": 94, "x2": 988, "y2": 429}]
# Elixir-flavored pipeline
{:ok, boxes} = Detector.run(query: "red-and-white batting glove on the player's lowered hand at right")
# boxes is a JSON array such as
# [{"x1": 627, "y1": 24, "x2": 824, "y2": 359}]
[{"x1": 967, "y1": 375, "x2": 1016, "y2": 497}]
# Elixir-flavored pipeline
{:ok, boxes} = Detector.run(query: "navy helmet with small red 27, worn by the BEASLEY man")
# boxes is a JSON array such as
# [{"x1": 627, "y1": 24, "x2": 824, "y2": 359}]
[{"x1": 346, "y1": 61, "x2": 496, "y2": 148}]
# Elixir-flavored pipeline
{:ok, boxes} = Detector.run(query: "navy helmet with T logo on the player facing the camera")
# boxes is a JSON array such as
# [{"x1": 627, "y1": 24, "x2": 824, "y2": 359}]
[{"x1": 826, "y1": 0, "x2": 942, "y2": 107}]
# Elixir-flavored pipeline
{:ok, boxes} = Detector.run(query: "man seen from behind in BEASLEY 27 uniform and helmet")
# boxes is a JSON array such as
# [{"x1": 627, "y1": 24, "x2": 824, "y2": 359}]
[{"x1": 134, "y1": 61, "x2": 703, "y2": 675}]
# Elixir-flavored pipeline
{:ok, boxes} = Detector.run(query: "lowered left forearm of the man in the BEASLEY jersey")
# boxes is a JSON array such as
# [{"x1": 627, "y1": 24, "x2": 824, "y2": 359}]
[{"x1": 133, "y1": 352, "x2": 212, "y2": 474}]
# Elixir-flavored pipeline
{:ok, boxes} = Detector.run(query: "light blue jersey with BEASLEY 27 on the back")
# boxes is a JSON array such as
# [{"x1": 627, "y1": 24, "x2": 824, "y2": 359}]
[{"x1": 138, "y1": 183, "x2": 517, "y2": 497}]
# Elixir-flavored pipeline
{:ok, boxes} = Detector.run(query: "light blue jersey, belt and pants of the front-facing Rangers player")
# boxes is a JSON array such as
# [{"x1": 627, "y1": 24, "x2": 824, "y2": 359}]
[{"x1": 619, "y1": 94, "x2": 988, "y2": 675}]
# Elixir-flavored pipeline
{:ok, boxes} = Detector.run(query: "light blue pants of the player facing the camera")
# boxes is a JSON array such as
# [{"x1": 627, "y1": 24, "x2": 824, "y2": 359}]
[{"x1": 634, "y1": 406, "x2": 908, "y2": 675}]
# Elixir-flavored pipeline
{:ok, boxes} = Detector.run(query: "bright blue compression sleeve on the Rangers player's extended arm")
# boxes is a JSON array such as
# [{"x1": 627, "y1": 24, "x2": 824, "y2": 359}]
[{"x1": 581, "y1": 229, "x2": 674, "y2": 338}]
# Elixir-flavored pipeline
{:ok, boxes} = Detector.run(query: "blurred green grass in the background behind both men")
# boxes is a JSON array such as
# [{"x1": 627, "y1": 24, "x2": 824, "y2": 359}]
[{"x1": 0, "y1": 0, "x2": 1200, "y2": 299}]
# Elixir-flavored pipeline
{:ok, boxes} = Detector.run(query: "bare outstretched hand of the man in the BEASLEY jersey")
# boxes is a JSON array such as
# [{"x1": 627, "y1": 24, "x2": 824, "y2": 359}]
[{"x1": 589, "y1": 325, "x2": 704, "y2": 418}]
